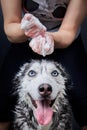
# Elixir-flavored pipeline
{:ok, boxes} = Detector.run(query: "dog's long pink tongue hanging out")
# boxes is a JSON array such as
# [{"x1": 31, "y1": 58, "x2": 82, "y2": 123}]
[{"x1": 35, "y1": 101, "x2": 53, "y2": 125}]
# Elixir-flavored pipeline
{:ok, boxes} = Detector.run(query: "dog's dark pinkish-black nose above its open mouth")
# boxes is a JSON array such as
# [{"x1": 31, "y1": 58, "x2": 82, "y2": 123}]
[{"x1": 39, "y1": 84, "x2": 52, "y2": 96}]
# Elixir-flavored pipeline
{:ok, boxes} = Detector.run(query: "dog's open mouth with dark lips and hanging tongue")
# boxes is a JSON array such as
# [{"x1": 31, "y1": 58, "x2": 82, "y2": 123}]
[{"x1": 28, "y1": 94, "x2": 55, "y2": 125}]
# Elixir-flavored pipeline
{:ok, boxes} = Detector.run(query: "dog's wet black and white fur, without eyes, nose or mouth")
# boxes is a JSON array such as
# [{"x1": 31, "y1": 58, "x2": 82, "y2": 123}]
[{"x1": 14, "y1": 60, "x2": 72, "y2": 130}]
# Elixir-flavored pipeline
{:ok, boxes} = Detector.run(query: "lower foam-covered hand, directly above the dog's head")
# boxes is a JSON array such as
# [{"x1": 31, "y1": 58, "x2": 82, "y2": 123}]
[{"x1": 29, "y1": 33, "x2": 54, "y2": 56}]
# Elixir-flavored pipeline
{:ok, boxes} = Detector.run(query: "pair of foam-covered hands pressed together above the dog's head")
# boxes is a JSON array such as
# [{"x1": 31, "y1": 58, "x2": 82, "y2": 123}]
[{"x1": 21, "y1": 13, "x2": 54, "y2": 56}]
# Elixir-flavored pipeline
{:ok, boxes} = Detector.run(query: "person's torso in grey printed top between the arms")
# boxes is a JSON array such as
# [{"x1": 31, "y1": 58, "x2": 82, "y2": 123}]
[{"x1": 23, "y1": 0, "x2": 70, "y2": 30}]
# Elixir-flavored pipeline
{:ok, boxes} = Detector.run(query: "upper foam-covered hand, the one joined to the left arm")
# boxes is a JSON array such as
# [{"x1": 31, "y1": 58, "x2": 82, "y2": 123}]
[{"x1": 21, "y1": 13, "x2": 46, "y2": 38}]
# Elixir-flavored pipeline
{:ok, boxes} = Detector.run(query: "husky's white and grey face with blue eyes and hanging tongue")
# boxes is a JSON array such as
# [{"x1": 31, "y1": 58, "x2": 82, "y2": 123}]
[{"x1": 15, "y1": 60, "x2": 66, "y2": 125}]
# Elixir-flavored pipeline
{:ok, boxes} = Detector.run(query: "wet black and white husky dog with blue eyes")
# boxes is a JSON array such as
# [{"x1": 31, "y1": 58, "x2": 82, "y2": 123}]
[{"x1": 14, "y1": 59, "x2": 72, "y2": 130}]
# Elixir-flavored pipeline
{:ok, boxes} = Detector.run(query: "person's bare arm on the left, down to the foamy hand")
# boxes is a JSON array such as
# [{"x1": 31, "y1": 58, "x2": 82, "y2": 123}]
[{"x1": 1, "y1": 0, "x2": 27, "y2": 43}]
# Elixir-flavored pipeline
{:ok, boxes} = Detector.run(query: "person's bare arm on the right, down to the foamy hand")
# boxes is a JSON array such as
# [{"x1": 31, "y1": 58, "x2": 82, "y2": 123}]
[{"x1": 52, "y1": 0, "x2": 87, "y2": 48}]
